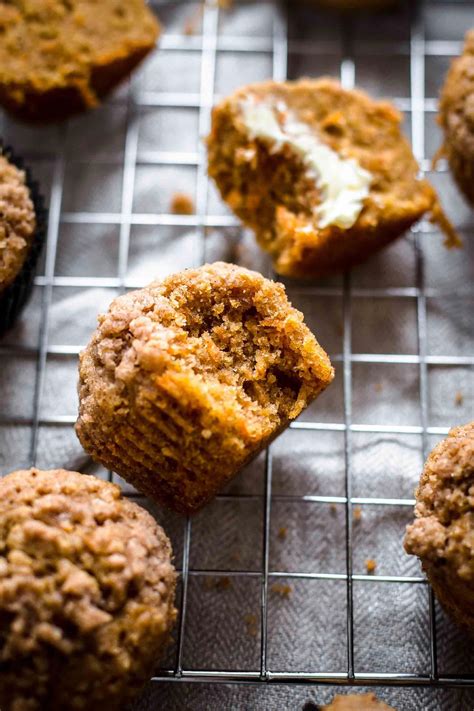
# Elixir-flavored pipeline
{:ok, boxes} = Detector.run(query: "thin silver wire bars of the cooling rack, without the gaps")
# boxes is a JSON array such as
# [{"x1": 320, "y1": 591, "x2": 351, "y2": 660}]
[{"x1": 0, "y1": 0, "x2": 474, "y2": 704}]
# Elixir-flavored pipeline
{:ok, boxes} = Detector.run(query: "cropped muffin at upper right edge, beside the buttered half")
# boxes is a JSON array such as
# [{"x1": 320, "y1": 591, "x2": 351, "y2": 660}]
[{"x1": 438, "y1": 30, "x2": 474, "y2": 204}]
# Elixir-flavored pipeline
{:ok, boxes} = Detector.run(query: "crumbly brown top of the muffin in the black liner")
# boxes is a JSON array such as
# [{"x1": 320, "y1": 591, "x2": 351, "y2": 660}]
[{"x1": 0, "y1": 155, "x2": 36, "y2": 293}]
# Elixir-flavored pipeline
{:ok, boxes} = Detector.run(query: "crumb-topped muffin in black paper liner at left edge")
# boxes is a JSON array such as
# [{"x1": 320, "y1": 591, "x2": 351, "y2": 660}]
[{"x1": 0, "y1": 144, "x2": 45, "y2": 334}]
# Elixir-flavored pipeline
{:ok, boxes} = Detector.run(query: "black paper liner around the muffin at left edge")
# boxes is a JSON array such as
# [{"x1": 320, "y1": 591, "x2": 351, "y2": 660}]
[{"x1": 0, "y1": 139, "x2": 47, "y2": 336}]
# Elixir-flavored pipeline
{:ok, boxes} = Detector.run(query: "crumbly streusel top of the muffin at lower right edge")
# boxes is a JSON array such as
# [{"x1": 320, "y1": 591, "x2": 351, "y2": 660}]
[{"x1": 405, "y1": 422, "x2": 474, "y2": 584}]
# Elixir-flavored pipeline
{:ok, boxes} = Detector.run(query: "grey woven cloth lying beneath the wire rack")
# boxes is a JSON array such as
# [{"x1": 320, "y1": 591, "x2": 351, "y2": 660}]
[{"x1": 0, "y1": 2, "x2": 474, "y2": 711}]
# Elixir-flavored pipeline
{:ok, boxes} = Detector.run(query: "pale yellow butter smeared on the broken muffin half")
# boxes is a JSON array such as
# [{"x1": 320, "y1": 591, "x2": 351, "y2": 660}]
[{"x1": 240, "y1": 96, "x2": 372, "y2": 229}]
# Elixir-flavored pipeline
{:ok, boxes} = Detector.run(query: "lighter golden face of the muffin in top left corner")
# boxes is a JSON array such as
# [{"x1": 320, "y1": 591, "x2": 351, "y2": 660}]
[{"x1": 0, "y1": 0, "x2": 159, "y2": 94}]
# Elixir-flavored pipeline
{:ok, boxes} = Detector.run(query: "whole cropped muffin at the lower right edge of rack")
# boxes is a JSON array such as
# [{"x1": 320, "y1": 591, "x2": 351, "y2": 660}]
[{"x1": 405, "y1": 422, "x2": 474, "y2": 636}]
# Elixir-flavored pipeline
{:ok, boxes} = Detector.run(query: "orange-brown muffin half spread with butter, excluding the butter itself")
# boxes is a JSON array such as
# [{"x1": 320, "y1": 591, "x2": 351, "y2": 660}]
[{"x1": 207, "y1": 78, "x2": 456, "y2": 277}]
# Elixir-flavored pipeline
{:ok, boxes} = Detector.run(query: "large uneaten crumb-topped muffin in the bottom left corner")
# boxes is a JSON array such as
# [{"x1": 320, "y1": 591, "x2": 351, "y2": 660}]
[{"x1": 0, "y1": 469, "x2": 176, "y2": 711}]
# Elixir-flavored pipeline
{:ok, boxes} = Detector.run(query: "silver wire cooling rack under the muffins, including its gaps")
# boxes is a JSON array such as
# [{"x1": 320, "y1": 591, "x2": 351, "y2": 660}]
[{"x1": 0, "y1": 0, "x2": 474, "y2": 709}]
